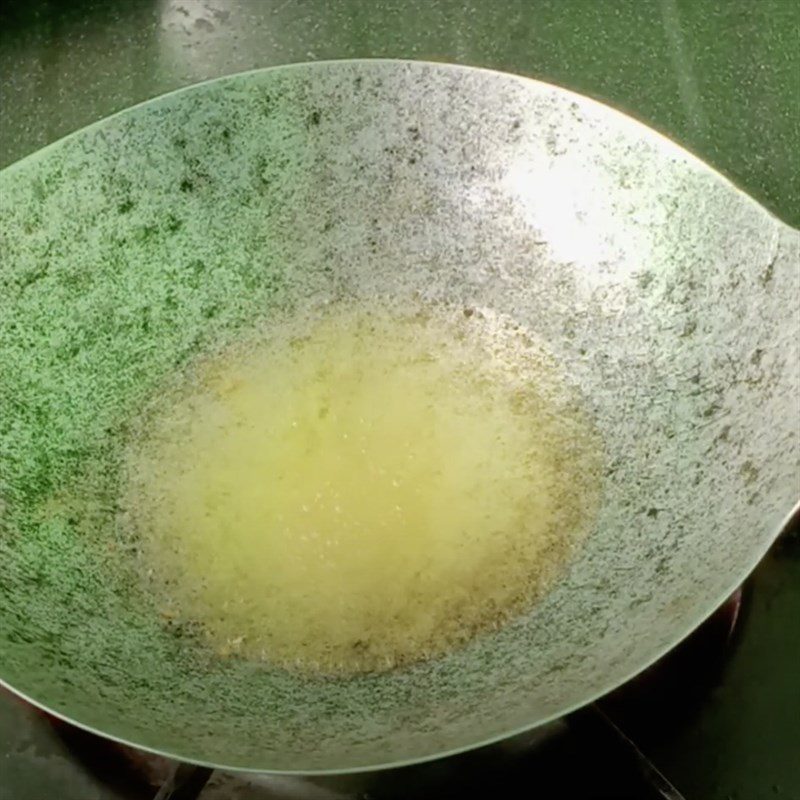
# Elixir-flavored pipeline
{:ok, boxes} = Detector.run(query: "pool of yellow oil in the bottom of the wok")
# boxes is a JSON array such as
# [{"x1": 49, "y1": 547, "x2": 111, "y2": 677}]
[{"x1": 124, "y1": 306, "x2": 600, "y2": 675}]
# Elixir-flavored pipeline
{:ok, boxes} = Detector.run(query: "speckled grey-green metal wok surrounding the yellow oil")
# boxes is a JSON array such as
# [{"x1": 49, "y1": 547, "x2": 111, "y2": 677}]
[{"x1": 0, "y1": 61, "x2": 800, "y2": 772}]
